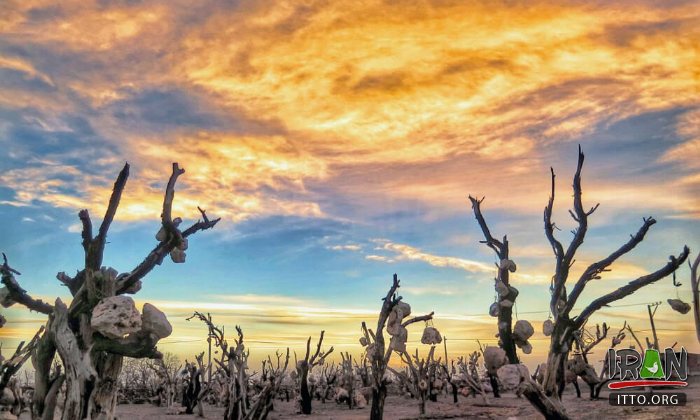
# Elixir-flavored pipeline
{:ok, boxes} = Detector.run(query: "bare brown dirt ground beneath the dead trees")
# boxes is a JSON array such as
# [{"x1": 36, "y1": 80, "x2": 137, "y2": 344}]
[{"x1": 117, "y1": 377, "x2": 700, "y2": 420}]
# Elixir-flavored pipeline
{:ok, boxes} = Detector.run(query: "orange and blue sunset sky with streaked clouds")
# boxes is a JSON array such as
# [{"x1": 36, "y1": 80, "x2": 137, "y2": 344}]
[{"x1": 0, "y1": 0, "x2": 700, "y2": 365}]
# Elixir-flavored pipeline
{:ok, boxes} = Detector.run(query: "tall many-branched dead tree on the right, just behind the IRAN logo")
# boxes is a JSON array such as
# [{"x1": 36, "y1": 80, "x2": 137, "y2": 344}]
[{"x1": 522, "y1": 146, "x2": 689, "y2": 418}]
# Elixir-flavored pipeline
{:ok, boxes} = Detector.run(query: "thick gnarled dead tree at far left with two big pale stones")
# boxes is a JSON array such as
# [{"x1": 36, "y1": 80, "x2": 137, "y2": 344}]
[{"x1": 0, "y1": 163, "x2": 219, "y2": 420}]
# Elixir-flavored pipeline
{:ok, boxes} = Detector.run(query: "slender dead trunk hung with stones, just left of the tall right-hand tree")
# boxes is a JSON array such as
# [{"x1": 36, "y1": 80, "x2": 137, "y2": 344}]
[{"x1": 469, "y1": 195, "x2": 520, "y2": 364}]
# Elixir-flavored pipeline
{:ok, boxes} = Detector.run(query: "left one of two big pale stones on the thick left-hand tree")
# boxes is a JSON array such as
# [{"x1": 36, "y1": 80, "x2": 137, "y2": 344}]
[{"x1": 90, "y1": 296, "x2": 141, "y2": 338}]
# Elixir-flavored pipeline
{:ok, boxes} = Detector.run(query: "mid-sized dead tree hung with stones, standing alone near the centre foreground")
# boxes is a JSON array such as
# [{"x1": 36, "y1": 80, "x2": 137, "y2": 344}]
[{"x1": 360, "y1": 274, "x2": 434, "y2": 420}]
